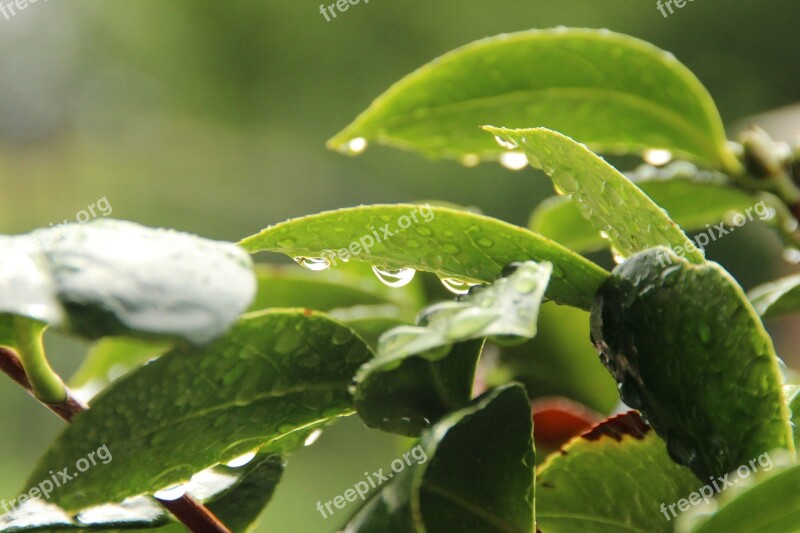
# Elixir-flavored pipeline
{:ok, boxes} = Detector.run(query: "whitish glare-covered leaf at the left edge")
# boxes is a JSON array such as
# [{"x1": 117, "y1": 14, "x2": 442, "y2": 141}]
[{"x1": 0, "y1": 220, "x2": 255, "y2": 344}]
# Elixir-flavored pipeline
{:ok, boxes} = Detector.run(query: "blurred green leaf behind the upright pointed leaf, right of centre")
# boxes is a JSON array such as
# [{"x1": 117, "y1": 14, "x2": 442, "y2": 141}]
[{"x1": 528, "y1": 179, "x2": 754, "y2": 252}]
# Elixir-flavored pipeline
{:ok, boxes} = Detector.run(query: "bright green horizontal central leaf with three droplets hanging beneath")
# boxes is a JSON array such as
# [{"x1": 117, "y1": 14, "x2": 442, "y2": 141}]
[{"x1": 240, "y1": 204, "x2": 607, "y2": 309}]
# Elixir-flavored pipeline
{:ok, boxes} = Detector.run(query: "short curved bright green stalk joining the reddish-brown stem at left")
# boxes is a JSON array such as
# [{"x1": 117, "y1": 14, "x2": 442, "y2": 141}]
[{"x1": 14, "y1": 317, "x2": 67, "y2": 404}]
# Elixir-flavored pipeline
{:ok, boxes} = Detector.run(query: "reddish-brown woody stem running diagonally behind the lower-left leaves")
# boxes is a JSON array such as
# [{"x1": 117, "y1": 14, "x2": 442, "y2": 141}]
[{"x1": 0, "y1": 347, "x2": 231, "y2": 533}]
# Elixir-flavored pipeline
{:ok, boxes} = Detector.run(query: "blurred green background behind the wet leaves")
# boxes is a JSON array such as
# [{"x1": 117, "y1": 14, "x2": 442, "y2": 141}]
[{"x1": 0, "y1": 0, "x2": 800, "y2": 533}]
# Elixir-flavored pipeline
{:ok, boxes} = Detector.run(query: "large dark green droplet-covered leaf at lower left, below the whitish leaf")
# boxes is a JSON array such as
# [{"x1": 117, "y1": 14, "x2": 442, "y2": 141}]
[{"x1": 22, "y1": 310, "x2": 369, "y2": 513}]
